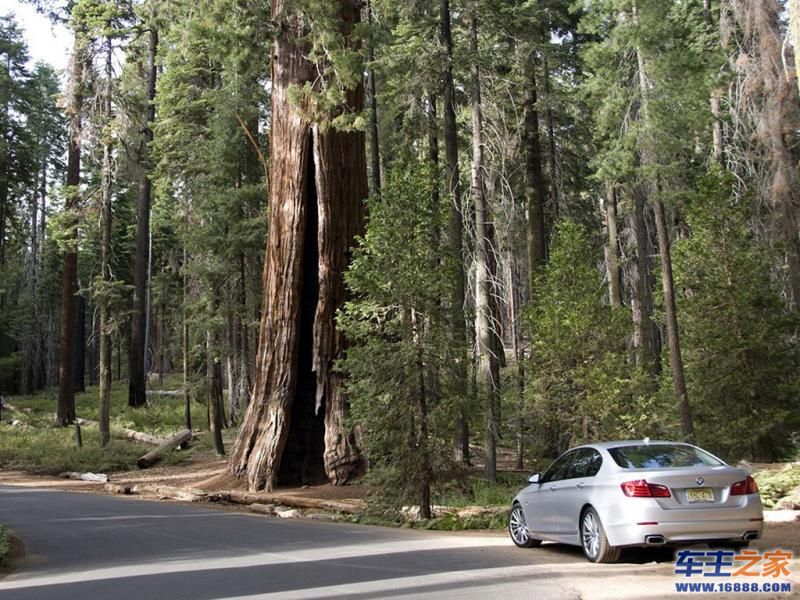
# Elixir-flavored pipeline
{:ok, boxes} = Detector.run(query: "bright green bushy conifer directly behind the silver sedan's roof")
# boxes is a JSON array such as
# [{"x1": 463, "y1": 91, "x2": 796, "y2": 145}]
[{"x1": 527, "y1": 220, "x2": 669, "y2": 453}]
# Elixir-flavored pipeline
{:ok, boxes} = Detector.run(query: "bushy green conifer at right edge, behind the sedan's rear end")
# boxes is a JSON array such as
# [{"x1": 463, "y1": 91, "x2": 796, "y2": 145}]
[{"x1": 673, "y1": 170, "x2": 800, "y2": 460}]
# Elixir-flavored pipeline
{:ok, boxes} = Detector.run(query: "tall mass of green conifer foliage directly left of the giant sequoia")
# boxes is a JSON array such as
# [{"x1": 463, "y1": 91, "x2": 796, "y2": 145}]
[{"x1": 153, "y1": 0, "x2": 269, "y2": 351}]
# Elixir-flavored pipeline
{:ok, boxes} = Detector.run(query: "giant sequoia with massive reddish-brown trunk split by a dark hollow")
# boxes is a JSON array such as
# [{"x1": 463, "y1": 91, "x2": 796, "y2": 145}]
[{"x1": 229, "y1": 0, "x2": 367, "y2": 490}]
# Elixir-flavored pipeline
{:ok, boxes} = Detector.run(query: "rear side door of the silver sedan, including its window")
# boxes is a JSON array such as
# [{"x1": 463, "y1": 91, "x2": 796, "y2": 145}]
[{"x1": 554, "y1": 448, "x2": 603, "y2": 539}]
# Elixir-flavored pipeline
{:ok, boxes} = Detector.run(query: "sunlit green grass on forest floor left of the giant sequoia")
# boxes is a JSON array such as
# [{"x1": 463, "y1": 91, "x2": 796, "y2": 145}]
[{"x1": 0, "y1": 382, "x2": 197, "y2": 475}]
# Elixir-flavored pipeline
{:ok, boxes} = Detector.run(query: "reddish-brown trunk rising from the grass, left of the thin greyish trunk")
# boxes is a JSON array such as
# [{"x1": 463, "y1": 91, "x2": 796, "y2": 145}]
[{"x1": 56, "y1": 33, "x2": 86, "y2": 426}]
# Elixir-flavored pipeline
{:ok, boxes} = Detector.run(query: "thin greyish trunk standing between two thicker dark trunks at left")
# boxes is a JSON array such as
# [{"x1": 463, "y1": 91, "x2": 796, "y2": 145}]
[{"x1": 99, "y1": 39, "x2": 113, "y2": 446}]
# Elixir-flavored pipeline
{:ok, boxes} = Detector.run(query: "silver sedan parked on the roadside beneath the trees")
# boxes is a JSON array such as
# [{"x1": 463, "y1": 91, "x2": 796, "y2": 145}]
[{"x1": 508, "y1": 440, "x2": 764, "y2": 562}]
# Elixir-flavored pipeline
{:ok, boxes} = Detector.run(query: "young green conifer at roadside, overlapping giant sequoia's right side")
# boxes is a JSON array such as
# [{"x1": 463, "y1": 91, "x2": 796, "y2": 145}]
[{"x1": 338, "y1": 159, "x2": 455, "y2": 506}]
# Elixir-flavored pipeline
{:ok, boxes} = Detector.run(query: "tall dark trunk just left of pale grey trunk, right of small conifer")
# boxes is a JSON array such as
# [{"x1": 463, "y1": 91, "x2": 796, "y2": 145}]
[{"x1": 439, "y1": 0, "x2": 469, "y2": 464}]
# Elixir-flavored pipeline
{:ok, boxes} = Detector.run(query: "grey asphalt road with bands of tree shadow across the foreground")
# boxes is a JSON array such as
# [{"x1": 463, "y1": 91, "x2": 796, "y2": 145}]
[{"x1": 0, "y1": 486, "x2": 700, "y2": 600}]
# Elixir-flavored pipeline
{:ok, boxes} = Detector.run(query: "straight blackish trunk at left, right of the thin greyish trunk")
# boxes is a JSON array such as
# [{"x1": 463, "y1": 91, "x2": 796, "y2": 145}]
[{"x1": 128, "y1": 28, "x2": 158, "y2": 407}]
